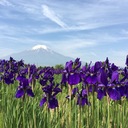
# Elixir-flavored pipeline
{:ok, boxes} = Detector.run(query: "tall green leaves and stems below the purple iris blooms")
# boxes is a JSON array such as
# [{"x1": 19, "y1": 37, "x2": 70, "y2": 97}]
[{"x1": 0, "y1": 76, "x2": 128, "y2": 128}]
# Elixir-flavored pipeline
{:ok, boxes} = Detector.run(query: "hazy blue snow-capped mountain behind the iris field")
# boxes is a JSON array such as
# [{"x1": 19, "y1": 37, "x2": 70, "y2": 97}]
[{"x1": 4, "y1": 45, "x2": 74, "y2": 66}]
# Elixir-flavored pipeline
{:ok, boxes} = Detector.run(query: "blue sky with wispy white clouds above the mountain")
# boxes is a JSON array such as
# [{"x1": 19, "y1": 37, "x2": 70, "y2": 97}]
[{"x1": 0, "y1": 0, "x2": 128, "y2": 66}]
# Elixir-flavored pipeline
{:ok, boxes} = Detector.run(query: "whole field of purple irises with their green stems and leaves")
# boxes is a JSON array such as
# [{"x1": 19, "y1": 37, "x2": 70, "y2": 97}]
[{"x1": 0, "y1": 56, "x2": 128, "y2": 128}]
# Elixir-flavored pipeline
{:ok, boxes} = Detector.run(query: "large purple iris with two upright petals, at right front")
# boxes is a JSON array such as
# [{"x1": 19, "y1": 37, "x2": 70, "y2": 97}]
[{"x1": 97, "y1": 69, "x2": 123, "y2": 100}]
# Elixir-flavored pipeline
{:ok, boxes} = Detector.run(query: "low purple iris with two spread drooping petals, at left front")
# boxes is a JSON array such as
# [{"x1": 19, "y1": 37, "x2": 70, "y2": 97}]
[{"x1": 15, "y1": 78, "x2": 34, "y2": 98}]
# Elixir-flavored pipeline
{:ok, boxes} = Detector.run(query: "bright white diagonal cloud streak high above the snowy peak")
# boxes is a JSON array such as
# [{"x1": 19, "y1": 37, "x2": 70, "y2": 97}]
[{"x1": 42, "y1": 5, "x2": 67, "y2": 28}]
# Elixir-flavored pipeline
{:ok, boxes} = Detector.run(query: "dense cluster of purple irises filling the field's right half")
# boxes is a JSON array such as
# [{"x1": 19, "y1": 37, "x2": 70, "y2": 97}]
[{"x1": 61, "y1": 56, "x2": 128, "y2": 106}]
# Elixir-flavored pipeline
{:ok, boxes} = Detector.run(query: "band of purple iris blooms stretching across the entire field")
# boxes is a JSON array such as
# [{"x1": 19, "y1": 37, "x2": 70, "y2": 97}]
[{"x1": 0, "y1": 55, "x2": 128, "y2": 109}]
